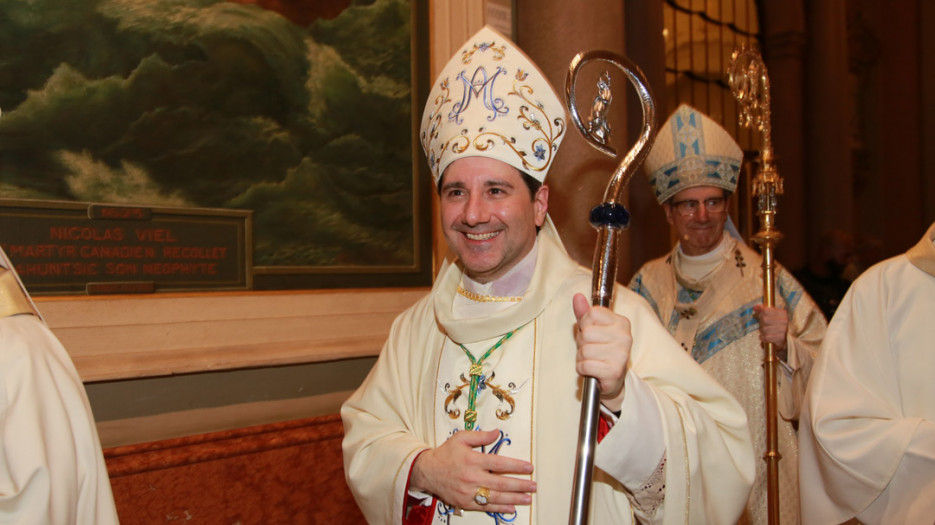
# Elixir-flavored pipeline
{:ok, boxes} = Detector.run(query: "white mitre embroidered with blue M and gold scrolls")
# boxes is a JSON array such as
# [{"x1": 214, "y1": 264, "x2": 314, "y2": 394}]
[{"x1": 419, "y1": 27, "x2": 565, "y2": 184}]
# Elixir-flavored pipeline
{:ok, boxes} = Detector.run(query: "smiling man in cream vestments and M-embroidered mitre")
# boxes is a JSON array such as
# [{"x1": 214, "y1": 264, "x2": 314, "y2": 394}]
[{"x1": 341, "y1": 28, "x2": 754, "y2": 524}]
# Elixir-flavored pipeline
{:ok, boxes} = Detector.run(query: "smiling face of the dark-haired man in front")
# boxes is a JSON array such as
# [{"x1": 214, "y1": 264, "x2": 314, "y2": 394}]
[{"x1": 440, "y1": 157, "x2": 549, "y2": 283}]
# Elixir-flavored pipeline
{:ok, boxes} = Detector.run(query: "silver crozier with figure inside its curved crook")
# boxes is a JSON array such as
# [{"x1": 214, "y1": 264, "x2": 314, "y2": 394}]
[{"x1": 565, "y1": 51, "x2": 657, "y2": 525}]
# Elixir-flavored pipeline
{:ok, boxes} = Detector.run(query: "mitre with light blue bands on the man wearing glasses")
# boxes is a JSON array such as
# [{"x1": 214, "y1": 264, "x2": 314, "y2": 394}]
[{"x1": 645, "y1": 104, "x2": 743, "y2": 204}]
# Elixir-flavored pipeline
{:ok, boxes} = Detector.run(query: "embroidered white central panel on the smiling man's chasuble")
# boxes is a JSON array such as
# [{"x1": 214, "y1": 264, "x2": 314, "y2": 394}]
[{"x1": 433, "y1": 323, "x2": 538, "y2": 525}]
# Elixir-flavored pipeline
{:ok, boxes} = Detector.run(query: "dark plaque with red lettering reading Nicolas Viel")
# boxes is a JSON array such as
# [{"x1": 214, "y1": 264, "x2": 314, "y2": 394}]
[{"x1": 0, "y1": 199, "x2": 252, "y2": 295}]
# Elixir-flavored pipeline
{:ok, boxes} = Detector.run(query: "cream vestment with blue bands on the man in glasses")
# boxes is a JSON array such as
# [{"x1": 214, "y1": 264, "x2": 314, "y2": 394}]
[{"x1": 630, "y1": 238, "x2": 824, "y2": 523}]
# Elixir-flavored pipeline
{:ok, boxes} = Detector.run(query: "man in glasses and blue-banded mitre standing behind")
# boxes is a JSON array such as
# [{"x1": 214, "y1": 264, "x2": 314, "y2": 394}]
[{"x1": 630, "y1": 105, "x2": 825, "y2": 523}]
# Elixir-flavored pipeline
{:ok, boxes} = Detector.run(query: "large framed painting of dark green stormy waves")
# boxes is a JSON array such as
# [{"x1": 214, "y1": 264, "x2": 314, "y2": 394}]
[{"x1": 0, "y1": 0, "x2": 431, "y2": 291}]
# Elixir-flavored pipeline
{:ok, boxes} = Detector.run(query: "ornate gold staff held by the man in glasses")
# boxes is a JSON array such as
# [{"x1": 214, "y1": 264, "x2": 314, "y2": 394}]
[{"x1": 727, "y1": 45, "x2": 782, "y2": 525}]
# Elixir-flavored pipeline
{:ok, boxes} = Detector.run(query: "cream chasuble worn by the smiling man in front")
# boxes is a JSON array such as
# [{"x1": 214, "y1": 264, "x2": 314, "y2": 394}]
[{"x1": 341, "y1": 228, "x2": 755, "y2": 525}]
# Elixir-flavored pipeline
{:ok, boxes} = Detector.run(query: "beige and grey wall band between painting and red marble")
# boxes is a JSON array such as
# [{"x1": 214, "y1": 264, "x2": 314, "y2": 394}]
[{"x1": 48, "y1": 288, "x2": 426, "y2": 446}]
